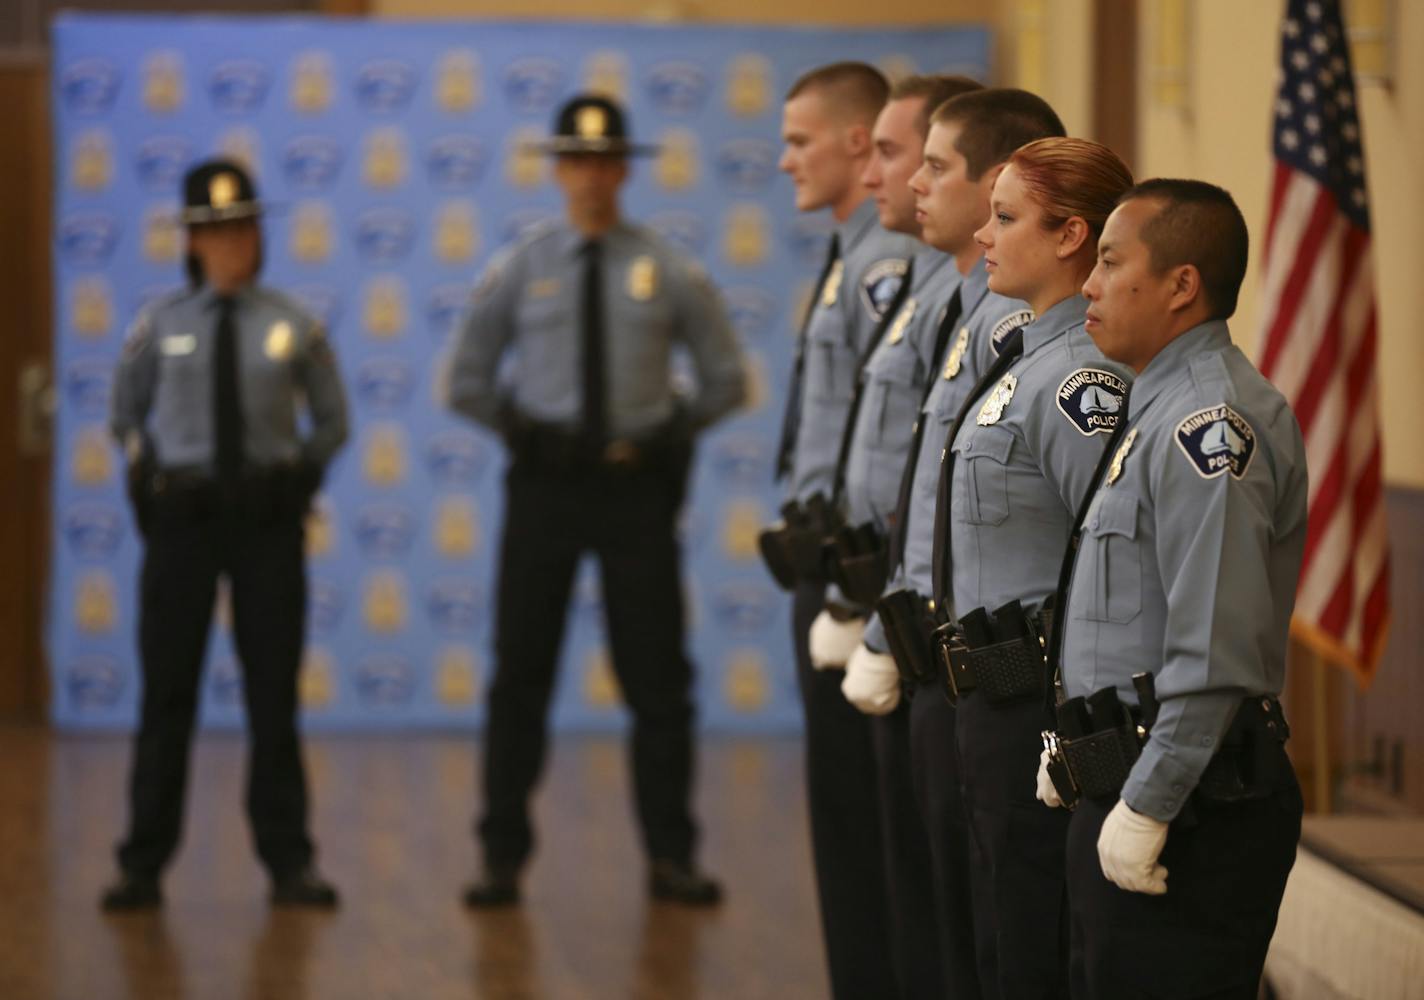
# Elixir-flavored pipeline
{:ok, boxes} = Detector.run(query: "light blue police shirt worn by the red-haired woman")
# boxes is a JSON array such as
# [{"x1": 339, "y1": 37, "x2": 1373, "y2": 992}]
[{"x1": 950, "y1": 295, "x2": 1131, "y2": 626}]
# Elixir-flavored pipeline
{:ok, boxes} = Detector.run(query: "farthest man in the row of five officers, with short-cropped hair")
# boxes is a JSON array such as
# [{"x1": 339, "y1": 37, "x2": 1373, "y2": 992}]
[{"x1": 773, "y1": 63, "x2": 916, "y2": 997}]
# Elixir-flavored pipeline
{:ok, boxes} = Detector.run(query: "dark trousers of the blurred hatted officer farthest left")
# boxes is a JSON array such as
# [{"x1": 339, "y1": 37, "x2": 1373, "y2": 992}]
[{"x1": 118, "y1": 491, "x2": 312, "y2": 877}]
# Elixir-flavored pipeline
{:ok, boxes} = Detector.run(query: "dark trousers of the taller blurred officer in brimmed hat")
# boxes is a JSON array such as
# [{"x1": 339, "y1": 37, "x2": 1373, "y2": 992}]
[{"x1": 478, "y1": 459, "x2": 696, "y2": 868}]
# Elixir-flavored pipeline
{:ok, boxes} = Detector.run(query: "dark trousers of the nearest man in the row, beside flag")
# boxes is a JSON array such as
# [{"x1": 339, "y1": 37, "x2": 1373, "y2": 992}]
[{"x1": 1068, "y1": 774, "x2": 1302, "y2": 1000}]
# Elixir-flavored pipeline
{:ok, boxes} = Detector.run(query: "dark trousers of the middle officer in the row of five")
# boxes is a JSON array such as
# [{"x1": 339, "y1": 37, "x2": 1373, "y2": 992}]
[{"x1": 910, "y1": 684, "x2": 990, "y2": 1000}]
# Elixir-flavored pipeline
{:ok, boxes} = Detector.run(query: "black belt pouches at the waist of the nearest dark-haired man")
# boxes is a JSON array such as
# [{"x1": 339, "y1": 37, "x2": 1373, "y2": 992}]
[{"x1": 1044, "y1": 674, "x2": 1158, "y2": 809}]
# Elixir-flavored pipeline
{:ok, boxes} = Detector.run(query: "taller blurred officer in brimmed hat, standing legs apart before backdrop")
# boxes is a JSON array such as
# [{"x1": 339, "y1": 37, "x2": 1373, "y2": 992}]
[{"x1": 447, "y1": 95, "x2": 745, "y2": 906}]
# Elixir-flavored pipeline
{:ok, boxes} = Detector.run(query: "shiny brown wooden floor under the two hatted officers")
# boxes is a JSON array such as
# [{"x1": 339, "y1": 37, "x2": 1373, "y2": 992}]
[{"x1": 0, "y1": 728, "x2": 826, "y2": 1000}]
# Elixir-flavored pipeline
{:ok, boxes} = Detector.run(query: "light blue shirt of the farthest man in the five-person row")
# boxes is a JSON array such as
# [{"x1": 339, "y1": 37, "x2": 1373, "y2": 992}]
[{"x1": 790, "y1": 198, "x2": 920, "y2": 500}]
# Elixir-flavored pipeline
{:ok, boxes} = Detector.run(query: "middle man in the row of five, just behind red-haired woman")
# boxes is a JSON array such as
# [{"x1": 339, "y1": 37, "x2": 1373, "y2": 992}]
[{"x1": 843, "y1": 88, "x2": 1064, "y2": 997}]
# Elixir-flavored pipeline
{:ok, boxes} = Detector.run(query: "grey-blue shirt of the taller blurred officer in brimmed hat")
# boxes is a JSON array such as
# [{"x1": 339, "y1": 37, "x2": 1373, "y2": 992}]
[{"x1": 447, "y1": 222, "x2": 746, "y2": 437}]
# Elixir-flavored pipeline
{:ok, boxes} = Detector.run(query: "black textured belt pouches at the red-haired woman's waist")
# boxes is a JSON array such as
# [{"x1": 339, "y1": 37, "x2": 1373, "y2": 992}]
[{"x1": 934, "y1": 601, "x2": 1048, "y2": 705}]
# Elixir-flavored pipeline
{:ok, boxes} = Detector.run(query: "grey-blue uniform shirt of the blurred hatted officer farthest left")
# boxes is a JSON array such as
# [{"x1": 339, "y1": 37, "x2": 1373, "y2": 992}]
[{"x1": 110, "y1": 286, "x2": 347, "y2": 472}]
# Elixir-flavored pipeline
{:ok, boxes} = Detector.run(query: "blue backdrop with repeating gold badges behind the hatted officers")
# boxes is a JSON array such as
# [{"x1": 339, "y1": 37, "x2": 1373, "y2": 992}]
[{"x1": 48, "y1": 16, "x2": 990, "y2": 731}]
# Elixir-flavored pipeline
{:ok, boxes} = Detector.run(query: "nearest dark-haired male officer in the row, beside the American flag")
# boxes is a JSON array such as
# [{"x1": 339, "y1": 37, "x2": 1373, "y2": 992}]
[{"x1": 1040, "y1": 179, "x2": 1307, "y2": 1000}]
